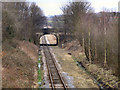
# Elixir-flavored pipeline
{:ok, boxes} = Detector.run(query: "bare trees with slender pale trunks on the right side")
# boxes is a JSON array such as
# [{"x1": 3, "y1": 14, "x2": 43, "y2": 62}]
[{"x1": 54, "y1": 1, "x2": 119, "y2": 75}]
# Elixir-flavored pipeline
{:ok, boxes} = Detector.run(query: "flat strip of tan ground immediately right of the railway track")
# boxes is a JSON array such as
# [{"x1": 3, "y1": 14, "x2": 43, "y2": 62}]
[{"x1": 45, "y1": 36, "x2": 98, "y2": 88}]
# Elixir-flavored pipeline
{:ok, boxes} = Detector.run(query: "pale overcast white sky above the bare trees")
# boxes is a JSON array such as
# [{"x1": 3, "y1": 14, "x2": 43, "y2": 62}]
[{"x1": 29, "y1": 0, "x2": 119, "y2": 16}]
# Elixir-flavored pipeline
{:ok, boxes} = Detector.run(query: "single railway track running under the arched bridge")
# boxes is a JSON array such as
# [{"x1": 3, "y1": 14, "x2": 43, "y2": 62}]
[{"x1": 42, "y1": 36, "x2": 67, "y2": 89}]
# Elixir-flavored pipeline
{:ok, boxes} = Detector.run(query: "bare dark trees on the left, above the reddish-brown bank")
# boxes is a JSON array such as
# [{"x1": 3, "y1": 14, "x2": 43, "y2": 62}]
[{"x1": 2, "y1": 2, "x2": 46, "y2": 43}]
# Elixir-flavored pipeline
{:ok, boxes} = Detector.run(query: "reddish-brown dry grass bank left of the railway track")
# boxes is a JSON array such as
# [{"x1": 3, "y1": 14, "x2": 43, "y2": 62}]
[{"x1": 2, "y1": 40, "x2": 37, "y2": 88}]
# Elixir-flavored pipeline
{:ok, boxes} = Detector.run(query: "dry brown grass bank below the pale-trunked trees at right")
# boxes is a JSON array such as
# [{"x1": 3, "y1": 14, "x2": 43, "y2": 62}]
[{"x1": 62, "y1": 41, "x2": 118, "y2": 88}]
